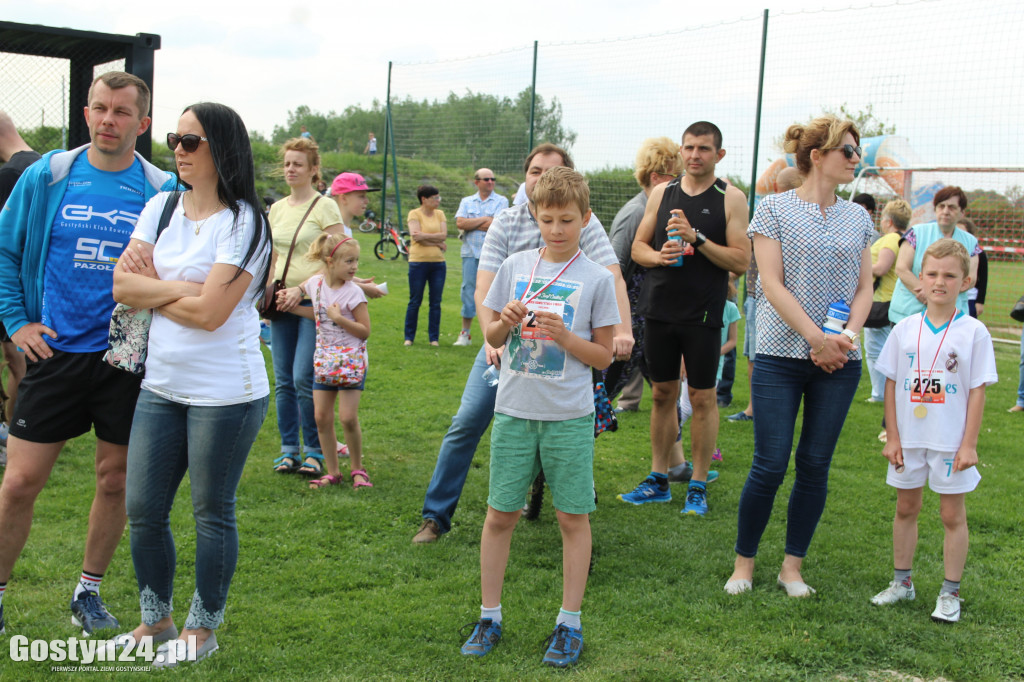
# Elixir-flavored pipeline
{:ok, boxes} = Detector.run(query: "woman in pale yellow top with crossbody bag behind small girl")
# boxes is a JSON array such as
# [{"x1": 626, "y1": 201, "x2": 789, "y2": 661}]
[{"x1": 269, "y1": 137, "x2": 344, "y2": 476}]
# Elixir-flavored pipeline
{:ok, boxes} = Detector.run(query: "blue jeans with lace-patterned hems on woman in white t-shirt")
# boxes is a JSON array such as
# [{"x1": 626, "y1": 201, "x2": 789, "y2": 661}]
[{"x1": 125, "y1": 390, "x2": 269, "y2": 630}]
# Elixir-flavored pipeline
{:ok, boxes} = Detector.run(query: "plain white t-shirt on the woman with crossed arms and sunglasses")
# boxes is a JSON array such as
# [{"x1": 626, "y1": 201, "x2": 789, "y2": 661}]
[{"x1": 131, "y1": 194, "x2": 270, "y2": 406}]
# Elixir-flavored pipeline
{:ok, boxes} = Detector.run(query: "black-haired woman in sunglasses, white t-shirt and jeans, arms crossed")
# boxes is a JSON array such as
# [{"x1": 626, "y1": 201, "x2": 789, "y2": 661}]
[{"x1": 114, "y1": 102, "x2": 270, "y2": 666}]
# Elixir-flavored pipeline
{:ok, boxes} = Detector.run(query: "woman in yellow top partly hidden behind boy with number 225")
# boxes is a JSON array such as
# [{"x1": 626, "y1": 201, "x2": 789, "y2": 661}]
[{"x1": 864, "y1": 199, "x2": 911, "y2": 402}]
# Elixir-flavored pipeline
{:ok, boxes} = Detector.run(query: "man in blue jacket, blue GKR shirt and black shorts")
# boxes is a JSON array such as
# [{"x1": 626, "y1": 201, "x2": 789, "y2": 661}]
[{"x1": 0, "y1": 72, "x2": 175, "y2": 636}]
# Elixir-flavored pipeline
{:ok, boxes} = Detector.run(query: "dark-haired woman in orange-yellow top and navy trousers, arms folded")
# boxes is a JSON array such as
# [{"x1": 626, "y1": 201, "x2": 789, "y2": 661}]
[{"x1": 406, "y1": 184, "x2": 447, "y2": 346}]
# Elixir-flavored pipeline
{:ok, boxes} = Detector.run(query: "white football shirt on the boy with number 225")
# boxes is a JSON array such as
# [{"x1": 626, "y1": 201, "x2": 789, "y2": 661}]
[{"x1": 874, "y1": 312, "x2": 997, "y2": 446}]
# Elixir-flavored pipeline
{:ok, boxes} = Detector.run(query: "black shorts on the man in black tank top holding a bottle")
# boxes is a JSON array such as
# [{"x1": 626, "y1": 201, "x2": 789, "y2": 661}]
[{"x1": 643, "y1": 317, "x2": 722, "y2": 390}]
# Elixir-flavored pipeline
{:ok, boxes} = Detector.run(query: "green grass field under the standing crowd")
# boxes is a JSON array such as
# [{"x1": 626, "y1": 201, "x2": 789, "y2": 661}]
[{"x1": 0, "y1": 235, "x2": 1024, "y2": 682}]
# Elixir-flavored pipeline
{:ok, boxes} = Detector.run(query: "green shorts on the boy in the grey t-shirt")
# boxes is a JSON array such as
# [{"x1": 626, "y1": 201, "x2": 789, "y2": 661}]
[{"x1": 487, "y1": 414, "x2": 597, "y2": 514}]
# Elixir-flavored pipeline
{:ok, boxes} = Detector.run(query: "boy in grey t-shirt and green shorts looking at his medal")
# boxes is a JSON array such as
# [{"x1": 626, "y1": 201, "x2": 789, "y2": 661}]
[{"x1": 462, "y1": 167, "x2": 618, "y2": 668}]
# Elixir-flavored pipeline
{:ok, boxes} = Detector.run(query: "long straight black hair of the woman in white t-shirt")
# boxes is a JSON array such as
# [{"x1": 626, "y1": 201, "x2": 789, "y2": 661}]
[{"x1": 175, "y1": 101, "x2": 270, "y2": 300}]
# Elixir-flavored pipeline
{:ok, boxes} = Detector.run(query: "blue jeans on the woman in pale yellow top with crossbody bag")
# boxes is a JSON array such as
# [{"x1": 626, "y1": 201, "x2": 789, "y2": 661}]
[{"x1": 270, "y1": 313, "x2": 321, "y2": 454}]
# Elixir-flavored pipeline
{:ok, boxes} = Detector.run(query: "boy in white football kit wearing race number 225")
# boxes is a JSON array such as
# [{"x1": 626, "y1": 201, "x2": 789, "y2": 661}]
[{"x1": 871, "y1": 239, "x2": 996, "y2": 623}]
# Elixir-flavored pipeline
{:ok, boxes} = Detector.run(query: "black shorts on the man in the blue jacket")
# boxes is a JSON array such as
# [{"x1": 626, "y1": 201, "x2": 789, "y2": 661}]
[{"x1": 10, "y1": 348, "x2": 141, "y2": 445}]
